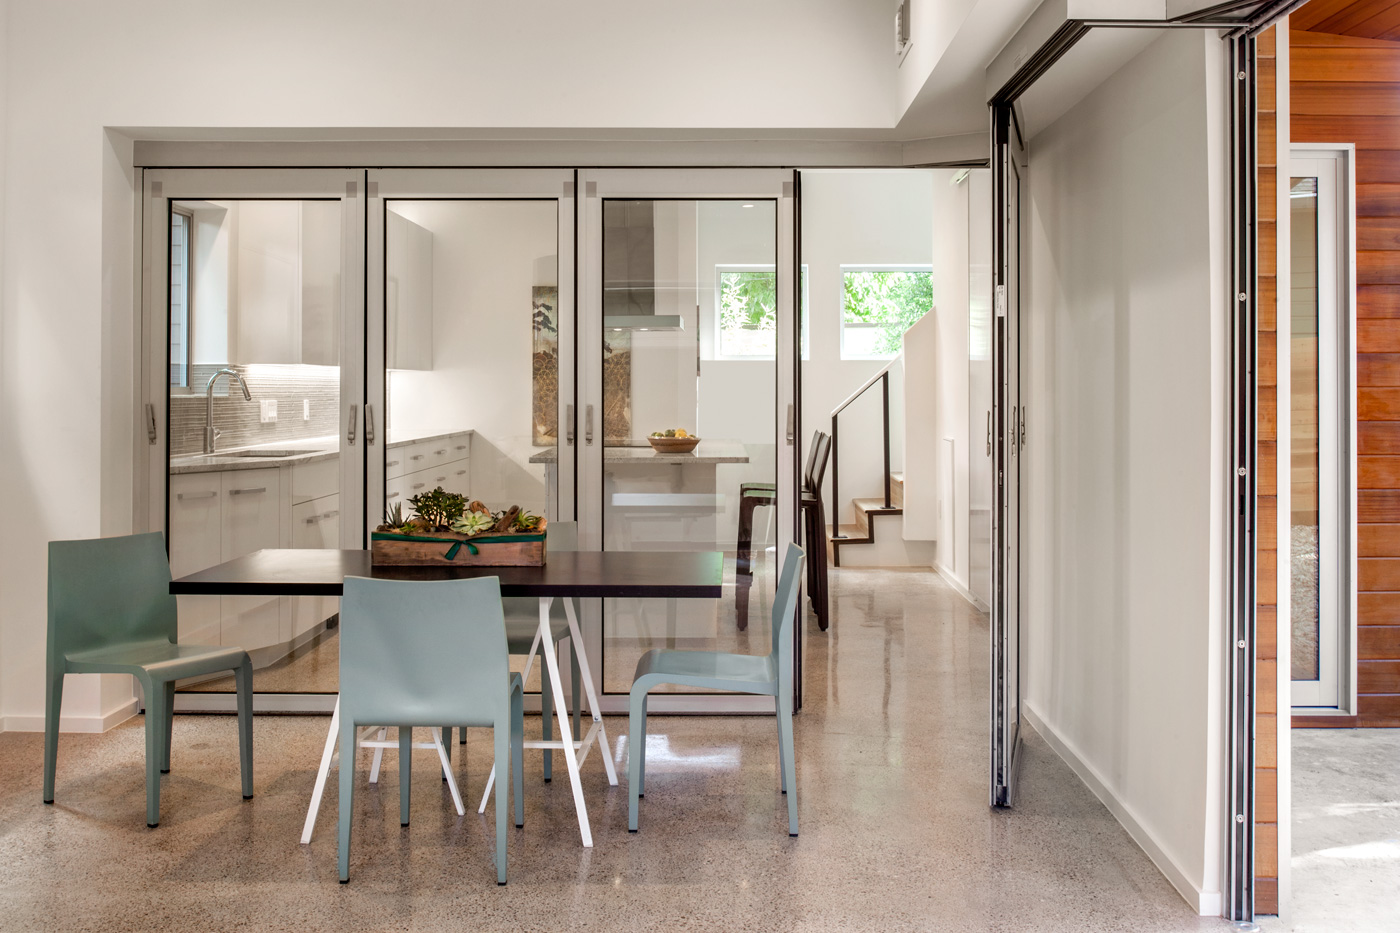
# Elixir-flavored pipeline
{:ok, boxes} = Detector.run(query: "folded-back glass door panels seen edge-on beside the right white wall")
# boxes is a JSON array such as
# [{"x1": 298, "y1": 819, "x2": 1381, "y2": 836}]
[{"x1": 991, "y1": 106, "x2": 1025, "y2": 807}]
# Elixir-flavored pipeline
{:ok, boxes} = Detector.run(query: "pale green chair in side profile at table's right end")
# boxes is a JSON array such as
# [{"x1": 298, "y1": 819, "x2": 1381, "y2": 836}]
[{"x1": 627, "y1": 544, "x2": 805, "y2": 836}]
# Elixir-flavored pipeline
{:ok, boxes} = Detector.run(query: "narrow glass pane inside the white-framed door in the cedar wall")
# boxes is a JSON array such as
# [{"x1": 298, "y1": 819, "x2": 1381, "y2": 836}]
[{"x1": 1289, "y1": 178, "x2": 1322, "y2": 681}]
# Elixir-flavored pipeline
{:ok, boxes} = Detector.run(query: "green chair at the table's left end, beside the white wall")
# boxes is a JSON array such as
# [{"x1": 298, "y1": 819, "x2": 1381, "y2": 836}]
[{"x1": 43, "y1": 532, "x2": 253, "y2": 828}]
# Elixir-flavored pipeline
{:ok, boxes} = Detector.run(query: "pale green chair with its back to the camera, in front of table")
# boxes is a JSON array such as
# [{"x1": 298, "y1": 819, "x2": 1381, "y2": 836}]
[{"x1": 339, "y1": 577, "x2": 525, "y2": 884}]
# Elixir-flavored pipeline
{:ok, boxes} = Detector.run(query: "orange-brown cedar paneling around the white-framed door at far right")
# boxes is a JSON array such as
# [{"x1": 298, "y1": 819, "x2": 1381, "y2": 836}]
[{"x1": 1288, "y1": 23, "x2": 1400, "y2": 727}]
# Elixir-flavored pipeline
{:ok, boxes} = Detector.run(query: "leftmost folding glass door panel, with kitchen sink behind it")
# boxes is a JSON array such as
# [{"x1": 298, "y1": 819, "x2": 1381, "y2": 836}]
[{"x1": 143, "y1": 170, "x2": 364, "y2": 709}]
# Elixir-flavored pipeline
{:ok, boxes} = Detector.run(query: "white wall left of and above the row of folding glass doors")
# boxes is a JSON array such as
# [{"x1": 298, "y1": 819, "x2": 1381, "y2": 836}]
[{"x1": 0, "y1": 0, "x2": 895, "y2": 721}]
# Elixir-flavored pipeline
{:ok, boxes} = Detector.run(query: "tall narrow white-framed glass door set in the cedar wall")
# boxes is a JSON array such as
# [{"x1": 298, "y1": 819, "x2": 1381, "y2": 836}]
[{"x1": 1278, "y1": 146, "x2": 1357, "y2": 713}]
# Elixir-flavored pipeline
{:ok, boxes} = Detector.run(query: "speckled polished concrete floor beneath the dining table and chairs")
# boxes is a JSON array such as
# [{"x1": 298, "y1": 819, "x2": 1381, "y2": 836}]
[{"x1": 0, "y1": 569, "x2": 1228, "y2": 933}]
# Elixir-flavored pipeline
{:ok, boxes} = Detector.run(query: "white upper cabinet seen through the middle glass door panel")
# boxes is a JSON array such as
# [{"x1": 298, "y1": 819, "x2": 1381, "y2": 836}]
[{"x1": 384, "y1": 210, "x2": 433, "y2": 370}]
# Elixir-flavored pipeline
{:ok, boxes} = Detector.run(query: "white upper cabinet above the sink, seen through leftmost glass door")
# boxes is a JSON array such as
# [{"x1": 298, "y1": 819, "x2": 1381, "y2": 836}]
[{"x1": 229, "y1": 200, "x2": 340, "y2": 366}]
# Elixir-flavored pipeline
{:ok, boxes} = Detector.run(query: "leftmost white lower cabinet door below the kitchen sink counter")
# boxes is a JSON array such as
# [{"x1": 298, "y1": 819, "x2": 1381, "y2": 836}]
[{"x1": 169, "y1": 474, "x2": 223, "y2": 644}]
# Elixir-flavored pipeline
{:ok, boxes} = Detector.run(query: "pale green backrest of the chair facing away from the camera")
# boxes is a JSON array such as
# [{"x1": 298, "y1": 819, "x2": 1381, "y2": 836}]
[{"x1": 340, "y1": 577, "x2": 510, "y2": 726}]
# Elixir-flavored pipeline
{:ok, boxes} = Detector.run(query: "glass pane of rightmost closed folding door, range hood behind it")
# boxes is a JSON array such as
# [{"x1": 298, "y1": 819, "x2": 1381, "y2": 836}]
[{"x1": 599, "y1": 200, "x2": 777, "y2": 693}]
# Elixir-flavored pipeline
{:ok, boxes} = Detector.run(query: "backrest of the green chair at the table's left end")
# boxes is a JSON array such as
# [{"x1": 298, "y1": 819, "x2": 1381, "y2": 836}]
[{"x1": 49, "y1": 531, "x2": 179, "y2": 664}]
